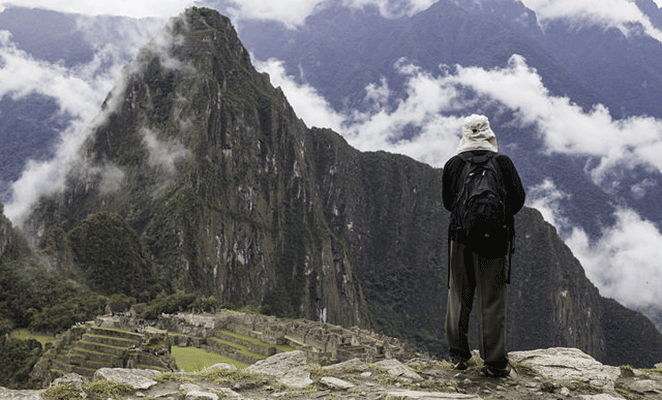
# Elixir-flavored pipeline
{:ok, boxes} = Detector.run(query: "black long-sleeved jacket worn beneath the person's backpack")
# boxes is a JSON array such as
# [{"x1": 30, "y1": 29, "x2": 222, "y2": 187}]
[{"x1": 441, "y1": 150, "x2": 526, "y2": 241}]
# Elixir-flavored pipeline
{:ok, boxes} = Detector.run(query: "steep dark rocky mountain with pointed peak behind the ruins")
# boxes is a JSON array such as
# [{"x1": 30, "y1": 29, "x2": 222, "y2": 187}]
[{"x1": 19, "y1": 8, "x2": 662, "y2": 365}]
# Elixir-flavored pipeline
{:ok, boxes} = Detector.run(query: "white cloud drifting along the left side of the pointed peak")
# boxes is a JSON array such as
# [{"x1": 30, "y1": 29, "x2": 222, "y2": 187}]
[{"x1": 0, "y1": 14, "x2": 173, "y2": 225}]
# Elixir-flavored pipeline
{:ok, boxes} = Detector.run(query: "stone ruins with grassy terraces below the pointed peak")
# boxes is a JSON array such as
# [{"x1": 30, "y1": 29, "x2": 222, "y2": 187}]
[{"x1": 32, "y1": 309, "x2": 416, "y2": 385}]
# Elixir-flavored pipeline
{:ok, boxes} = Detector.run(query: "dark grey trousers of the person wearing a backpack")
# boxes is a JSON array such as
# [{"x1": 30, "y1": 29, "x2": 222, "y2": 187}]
[{"x1": 446, "y1": 241, "x2": 510, "y2": 368}]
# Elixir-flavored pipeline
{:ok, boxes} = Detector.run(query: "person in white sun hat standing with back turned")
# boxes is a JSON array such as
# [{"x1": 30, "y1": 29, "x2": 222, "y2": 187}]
[{"x1": 442, "y1": 114, "x2": 526, "y2": 377}]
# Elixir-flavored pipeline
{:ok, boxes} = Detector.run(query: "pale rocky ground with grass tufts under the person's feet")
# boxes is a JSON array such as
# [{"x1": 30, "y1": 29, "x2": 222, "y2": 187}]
[{"x1": 0, "y1": 348, "x2": 662, "y2": 400}]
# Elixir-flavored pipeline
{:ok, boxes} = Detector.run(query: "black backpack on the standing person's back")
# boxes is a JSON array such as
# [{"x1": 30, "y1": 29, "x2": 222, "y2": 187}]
[{"x1": 453, "y1": 152, "x2": 510, "y2": 257}]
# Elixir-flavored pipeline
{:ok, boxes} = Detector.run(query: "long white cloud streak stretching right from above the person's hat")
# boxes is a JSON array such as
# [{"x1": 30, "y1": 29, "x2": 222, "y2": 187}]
[{"x1": 450, "y1": 55, "x2": 662, "y2": 180}]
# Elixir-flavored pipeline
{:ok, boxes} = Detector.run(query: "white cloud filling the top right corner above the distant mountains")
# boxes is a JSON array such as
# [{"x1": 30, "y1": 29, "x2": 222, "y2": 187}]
[{"x1": 522, "y1": 0, "x2": 662, "y2": 42}]
